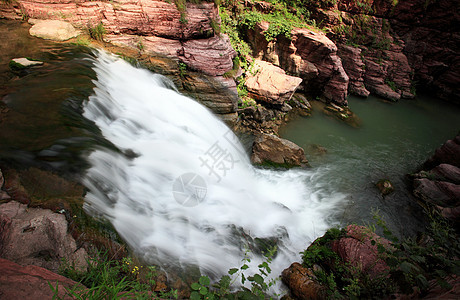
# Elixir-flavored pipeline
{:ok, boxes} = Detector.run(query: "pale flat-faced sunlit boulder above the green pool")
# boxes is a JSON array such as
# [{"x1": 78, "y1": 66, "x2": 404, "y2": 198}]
[{"x1": 246, "y1": 60, "x2": 302, "y2": 105}]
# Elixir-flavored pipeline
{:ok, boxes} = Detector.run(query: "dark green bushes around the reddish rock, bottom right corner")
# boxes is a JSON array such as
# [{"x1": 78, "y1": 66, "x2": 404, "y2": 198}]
[{"x1": 302, "y1": 214, "x2": 460, "y2": 299}]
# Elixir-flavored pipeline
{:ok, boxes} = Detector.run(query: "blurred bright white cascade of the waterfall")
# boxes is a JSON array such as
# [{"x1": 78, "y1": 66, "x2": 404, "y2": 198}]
[{"x1": 84, "y1": 52, "x2": 345, "y2": 288}]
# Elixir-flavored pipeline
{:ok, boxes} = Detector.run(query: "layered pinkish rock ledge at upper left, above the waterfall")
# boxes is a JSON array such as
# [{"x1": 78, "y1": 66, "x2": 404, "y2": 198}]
[{"x1": 3, "y1": 0, "x2": 238, "y2": 119}]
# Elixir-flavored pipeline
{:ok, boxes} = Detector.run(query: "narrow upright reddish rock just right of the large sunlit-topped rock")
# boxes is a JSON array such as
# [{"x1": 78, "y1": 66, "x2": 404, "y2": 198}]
[{"x1": 337, "y1": 44, "x2": 370, "y2": 97}]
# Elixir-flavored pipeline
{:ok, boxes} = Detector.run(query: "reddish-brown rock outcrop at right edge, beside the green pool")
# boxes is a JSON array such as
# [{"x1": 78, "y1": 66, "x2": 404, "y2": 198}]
[{"x1": 413, "y1": 135, "x2": 460, "y2": 222}]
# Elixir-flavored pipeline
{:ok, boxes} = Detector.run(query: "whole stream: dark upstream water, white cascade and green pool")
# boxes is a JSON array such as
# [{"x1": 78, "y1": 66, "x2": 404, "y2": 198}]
[{"x1": 0, "y1": 21, "x2": 460, "y2": 290}]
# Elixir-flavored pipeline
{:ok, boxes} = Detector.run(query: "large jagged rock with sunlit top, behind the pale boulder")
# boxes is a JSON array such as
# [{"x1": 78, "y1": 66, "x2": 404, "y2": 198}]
[{"x1": 248, "y1": 22, "x2": 348, "y2": 105}]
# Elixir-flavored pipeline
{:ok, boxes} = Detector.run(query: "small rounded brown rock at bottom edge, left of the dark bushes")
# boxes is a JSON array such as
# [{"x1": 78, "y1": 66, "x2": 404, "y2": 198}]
[{"x1": 281, "y1": 263, "x2": 325, "y2": 300}]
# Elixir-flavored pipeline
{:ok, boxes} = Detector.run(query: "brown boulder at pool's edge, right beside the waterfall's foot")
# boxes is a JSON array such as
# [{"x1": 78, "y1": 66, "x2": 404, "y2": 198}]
[{"x1": 251, "y1": 134, "x2": 308, "y2": 167}]
